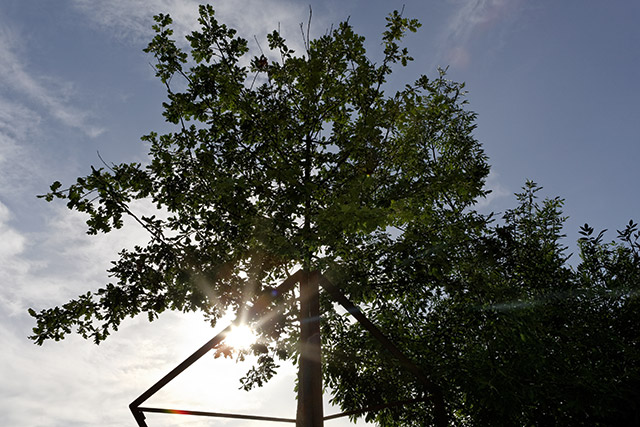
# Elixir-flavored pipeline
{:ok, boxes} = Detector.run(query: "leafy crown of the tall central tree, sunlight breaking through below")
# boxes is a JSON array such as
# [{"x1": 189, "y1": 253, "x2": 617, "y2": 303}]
[{"x1": 30, "y1": 6, "x2": 488, "y2": 427}]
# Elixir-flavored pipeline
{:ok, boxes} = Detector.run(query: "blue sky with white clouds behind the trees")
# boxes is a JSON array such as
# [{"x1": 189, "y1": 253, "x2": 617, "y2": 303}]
[{"x1": 0, "y1": 0, "x2": 640, "y2": 427}]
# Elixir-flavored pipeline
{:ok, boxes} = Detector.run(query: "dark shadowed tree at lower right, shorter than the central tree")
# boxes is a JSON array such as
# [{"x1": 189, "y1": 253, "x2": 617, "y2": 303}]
[{"x1": 328, "y1": 182, "x2": 640, "y2": 426}]
